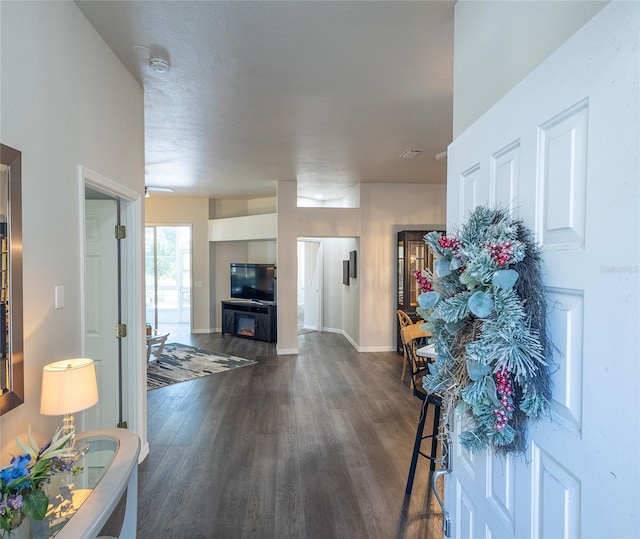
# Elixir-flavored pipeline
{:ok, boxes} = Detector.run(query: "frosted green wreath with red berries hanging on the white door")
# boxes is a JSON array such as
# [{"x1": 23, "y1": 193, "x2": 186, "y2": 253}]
[{"x1": 416, "y1": 206, "x2": 551, "y2": 454}]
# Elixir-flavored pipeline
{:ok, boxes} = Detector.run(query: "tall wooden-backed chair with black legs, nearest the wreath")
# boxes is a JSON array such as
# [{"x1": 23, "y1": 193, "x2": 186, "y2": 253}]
[{"x1": 400, "y1": 323, "x2": 442, "y2": 495}]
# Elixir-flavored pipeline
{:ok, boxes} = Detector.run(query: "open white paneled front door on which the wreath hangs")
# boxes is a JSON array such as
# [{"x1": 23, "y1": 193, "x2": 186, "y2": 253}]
[{"x1": 445, "y1": 2, "x2": 640, "y2": 539}]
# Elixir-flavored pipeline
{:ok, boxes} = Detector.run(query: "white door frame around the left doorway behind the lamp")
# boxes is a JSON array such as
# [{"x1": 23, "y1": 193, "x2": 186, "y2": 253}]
[{"x1": 78, "y1": 165, "x2": 149, "y2": 461}]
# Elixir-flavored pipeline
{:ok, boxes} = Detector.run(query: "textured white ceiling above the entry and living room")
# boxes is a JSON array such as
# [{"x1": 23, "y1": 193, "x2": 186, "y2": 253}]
[{"x1": 76, "y1": 0, "x2": 453, "y2": 200}]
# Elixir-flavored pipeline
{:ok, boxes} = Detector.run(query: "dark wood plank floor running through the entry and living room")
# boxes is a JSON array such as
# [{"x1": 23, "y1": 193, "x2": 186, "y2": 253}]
[{"x1": 102, "y1": 332, "x2": 442, "y2": 539}]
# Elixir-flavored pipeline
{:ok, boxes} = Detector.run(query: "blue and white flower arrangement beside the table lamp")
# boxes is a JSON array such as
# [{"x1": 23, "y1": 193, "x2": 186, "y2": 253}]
[{"x1": 0, "y1": 429, "x2": 73, "y2": 536}]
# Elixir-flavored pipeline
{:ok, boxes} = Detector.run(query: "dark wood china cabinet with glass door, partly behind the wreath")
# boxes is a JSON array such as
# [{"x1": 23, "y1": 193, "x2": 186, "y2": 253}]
[{"x1": 395, "y1": 229, "x2": 437, "y2": 352}]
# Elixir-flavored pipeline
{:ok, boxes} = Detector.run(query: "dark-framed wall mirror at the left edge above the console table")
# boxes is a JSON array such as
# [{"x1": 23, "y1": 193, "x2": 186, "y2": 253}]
[{"x1": 0, "y1": 144, "x2": 24, "y2": 415}]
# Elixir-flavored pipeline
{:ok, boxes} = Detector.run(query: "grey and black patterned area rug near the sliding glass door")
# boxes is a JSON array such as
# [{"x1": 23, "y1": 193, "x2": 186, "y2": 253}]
[{"x1": 147, "y1": 343, "x2": 257, "y2": 391}]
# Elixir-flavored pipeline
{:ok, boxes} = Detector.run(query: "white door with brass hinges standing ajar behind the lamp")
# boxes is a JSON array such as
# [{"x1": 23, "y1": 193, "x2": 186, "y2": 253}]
[{"x1": 85, "y1": 200, "x2": 120, "y2": 429}]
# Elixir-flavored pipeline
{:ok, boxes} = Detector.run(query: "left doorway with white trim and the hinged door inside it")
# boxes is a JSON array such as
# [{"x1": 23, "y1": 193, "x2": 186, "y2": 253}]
[{"x1": 78, "y1": 166, "x2": 148, "y2": 442}]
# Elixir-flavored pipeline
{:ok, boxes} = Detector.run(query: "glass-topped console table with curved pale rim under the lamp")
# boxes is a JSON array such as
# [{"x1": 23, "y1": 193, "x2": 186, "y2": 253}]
[{"x1": 30, "y1": 429, "x2": 140, "y2": 539}]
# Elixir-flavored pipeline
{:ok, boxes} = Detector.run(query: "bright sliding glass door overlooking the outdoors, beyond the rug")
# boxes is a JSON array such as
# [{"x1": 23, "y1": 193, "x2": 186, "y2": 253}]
[{"x1": 144, "y1": 225, "x2": 191, "y2": 335}]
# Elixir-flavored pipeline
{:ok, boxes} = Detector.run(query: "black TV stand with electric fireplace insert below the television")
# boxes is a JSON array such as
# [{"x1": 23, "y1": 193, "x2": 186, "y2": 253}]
[{"x1": 222, "y1": 300, "x2": 278, "y2": 342}]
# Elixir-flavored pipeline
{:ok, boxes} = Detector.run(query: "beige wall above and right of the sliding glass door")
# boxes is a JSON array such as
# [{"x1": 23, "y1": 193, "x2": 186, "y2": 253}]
[{"x1": 145, "y1": 193, "x2": 214, "y2": 333}]
